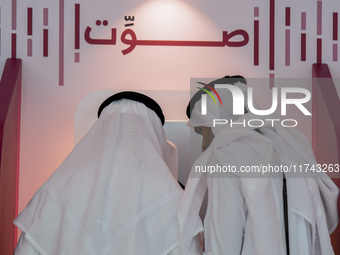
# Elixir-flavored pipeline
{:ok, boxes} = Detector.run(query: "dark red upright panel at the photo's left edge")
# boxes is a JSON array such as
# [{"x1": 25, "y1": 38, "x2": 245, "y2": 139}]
[{"x1": 0, "y1": 59, "x2": 21, "y2": 254}]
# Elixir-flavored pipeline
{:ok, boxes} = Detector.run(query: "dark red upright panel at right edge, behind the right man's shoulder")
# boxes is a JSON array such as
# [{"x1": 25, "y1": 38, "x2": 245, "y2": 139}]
[{"x1": 312, "y1": 64, "x2": 340, "y2": 254}]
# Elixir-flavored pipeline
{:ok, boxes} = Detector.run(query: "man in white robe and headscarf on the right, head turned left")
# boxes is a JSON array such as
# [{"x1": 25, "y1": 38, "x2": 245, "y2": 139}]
[{"x1": 179, "y1": 76, "x2": 339, "y2": 255}]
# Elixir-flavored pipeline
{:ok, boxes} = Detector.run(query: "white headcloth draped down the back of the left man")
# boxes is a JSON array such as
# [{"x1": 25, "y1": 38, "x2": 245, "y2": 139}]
[{"x1": 14, "y1": 99, "x2": 194, "y2": 255}]
